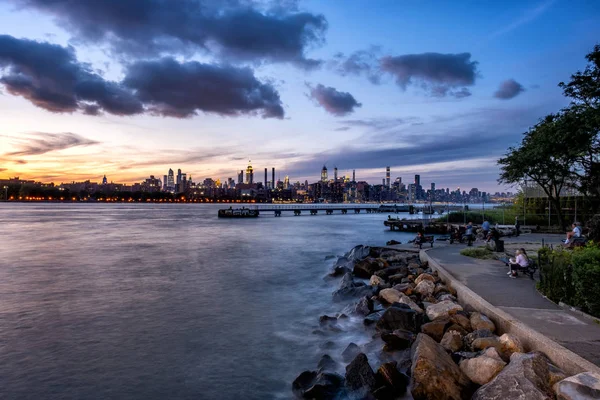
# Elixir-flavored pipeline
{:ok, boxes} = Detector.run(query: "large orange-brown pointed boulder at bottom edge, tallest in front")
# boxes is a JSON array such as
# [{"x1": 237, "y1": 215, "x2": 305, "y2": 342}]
[{"x1": 411, "y1": 334, "x2": 472, "y2": 400}]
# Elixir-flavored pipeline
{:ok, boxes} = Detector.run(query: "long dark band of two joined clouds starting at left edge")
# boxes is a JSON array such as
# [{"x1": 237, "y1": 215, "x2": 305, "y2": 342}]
[{"x1": 0, "y1": 35, "x2": 284, "y2": 118}]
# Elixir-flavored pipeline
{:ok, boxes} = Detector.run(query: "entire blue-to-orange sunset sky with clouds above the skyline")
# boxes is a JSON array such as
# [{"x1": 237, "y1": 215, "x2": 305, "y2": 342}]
[{"x1": 0, "y1": 0, "x2": 600, "y2": 192}]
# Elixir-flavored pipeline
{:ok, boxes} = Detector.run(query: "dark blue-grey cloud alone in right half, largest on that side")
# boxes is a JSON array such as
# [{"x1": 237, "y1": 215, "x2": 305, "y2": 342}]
[{"x1": 380, "y1": 53, "x2": 477, "y2": 97}]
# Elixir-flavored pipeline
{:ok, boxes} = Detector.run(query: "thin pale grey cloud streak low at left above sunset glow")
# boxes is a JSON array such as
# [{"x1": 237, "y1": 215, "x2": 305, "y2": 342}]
[{"x1": 6, "y1": 132, "x2": 99, "y2": 157}]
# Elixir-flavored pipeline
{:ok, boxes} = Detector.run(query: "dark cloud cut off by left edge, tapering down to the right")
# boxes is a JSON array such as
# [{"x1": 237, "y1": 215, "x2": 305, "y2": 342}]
[{"x1": 0, "y1": 35, "x2": 143, "y2": 115}]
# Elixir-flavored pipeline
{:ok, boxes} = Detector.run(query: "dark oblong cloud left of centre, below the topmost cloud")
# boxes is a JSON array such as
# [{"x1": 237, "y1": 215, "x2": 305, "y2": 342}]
[{"x1": 123, "y1": 58, "x2": 284, "y2": 118}]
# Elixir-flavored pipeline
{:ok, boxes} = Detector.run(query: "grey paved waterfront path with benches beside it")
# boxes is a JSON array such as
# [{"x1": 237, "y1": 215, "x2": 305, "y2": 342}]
[{"x1": 427, "y1": 234, "x2": 600, "y2": 366}]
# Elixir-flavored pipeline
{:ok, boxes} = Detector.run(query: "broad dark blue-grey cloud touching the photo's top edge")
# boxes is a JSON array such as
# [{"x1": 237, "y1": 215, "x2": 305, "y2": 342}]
[{"x1": 12, "y1": 0, "x2": 327, "y2": 68}]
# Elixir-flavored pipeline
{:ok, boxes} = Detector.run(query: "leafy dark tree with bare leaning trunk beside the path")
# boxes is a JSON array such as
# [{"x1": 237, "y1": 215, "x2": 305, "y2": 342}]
[{"x1": 498, "y1": 113, "x2": 578, "y2": 230}]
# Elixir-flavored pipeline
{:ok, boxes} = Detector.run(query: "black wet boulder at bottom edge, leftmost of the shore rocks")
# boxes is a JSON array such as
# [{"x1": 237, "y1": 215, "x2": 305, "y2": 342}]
[{"x1": 292, "y1": 371, "x2": 344, "y2": 399}]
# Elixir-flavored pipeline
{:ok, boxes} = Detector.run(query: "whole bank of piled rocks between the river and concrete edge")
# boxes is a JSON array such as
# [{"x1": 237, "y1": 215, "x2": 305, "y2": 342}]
[{"x1": 292, "y1": 245, "x2": 600, "y2": 400}]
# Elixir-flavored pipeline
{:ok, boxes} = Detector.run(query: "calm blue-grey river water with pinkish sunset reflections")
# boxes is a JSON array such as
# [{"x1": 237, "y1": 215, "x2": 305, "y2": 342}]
[{"x1": 0, "y1": 204, "x2": 420, "y2": 399}]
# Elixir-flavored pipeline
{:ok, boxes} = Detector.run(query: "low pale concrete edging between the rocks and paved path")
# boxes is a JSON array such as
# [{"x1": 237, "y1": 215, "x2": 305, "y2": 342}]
[{"x1": 420, "y1": 250, "x2": 600, "y2": 375}]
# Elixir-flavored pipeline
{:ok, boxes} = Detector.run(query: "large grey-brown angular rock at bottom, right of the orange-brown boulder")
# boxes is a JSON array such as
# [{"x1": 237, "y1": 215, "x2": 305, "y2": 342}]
[{"x1": 473, "y1": 352, "x2": 554, "y2": 400}]
